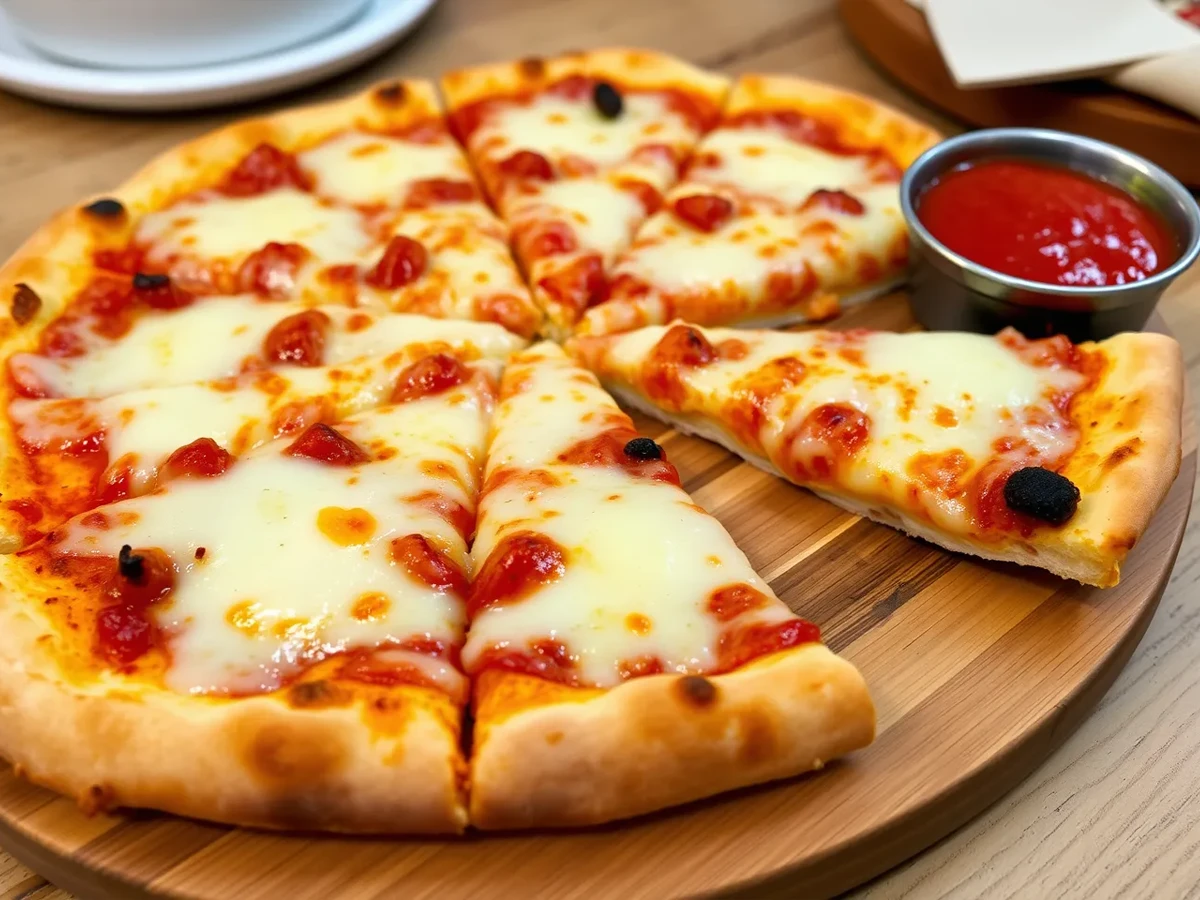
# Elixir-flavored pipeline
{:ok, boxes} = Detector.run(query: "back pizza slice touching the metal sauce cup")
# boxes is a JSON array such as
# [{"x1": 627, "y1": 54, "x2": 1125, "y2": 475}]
[{"x1": 580, "y1": 74, "x2": 938, "y2": 334}]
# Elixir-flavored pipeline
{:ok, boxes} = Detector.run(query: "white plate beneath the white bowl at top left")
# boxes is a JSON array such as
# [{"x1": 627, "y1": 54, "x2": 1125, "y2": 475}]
[{"x1": 0, "y1": 0, "x2": 437, "y2": 110}]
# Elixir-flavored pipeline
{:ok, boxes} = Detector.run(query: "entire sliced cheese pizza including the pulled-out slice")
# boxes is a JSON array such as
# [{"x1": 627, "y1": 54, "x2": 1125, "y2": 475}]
[{"x1": 0, "y1": 49, "x2": 1182, "y2": 833}]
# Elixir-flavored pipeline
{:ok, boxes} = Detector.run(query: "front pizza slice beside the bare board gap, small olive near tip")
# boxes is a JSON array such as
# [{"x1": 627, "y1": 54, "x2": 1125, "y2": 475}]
[{"x1": 462, "y1": 343, "x2": 875, "y2": 828}]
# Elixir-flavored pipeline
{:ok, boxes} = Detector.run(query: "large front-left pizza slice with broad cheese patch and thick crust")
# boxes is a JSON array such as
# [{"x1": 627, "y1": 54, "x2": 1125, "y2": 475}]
[{"x1": 0, "y1": 362, "x2": 494, "y2": 832}]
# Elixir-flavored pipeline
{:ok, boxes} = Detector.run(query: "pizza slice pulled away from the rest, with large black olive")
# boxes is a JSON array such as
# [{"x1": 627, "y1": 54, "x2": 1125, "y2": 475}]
[{"x1": 574, "y1": 323, "x2": 1183, "y2": 587}]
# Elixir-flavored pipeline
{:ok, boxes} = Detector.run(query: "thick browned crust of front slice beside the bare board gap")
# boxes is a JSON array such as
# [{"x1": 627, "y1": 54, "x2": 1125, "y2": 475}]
[{"x1": 470, "y1": 644, "x2": 875, "y2": 829}]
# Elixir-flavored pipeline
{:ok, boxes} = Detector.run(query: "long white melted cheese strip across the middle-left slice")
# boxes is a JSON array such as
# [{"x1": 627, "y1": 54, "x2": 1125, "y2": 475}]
[{"x1": 10, "y1": 303, "x2": 524, "y2": 397}]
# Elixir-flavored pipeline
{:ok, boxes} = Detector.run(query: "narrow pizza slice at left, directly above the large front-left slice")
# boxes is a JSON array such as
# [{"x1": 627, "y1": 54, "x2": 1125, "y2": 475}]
[{"x1": 0, "y1": 343, "x2": 499, "y2": 552}]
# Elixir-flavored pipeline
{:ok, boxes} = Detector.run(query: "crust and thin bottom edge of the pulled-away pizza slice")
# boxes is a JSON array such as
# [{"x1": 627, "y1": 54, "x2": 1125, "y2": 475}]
[{"x1": 590, "y1": 332, "x2": 1183, "y2": 588}]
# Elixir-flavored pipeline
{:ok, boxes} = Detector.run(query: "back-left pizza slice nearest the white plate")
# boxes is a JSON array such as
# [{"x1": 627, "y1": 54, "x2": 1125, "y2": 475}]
[{"x1": 4, "y1": 82, "x2": 538, "y2": 336}]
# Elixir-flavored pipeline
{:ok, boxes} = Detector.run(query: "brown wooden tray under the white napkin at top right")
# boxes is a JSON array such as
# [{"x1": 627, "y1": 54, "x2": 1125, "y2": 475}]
[{"x1": 839, "y1": 0, "x2": 1200, "y2": 188}]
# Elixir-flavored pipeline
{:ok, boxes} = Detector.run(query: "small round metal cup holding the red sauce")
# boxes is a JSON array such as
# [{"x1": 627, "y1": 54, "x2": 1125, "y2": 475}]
[{"x1": 900, "y1": 128, "x2": 1200, "y2": 341}]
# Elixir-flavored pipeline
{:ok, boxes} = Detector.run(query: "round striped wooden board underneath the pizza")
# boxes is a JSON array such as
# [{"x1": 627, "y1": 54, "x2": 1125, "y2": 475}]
[{"x1": 0, "y1": 295, "x2": 1196, "y2": 900}]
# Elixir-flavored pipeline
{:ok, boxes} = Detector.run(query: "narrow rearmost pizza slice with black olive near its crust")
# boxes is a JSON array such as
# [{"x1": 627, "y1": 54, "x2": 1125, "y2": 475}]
[{"x1": 442, "y1": 49, "x2": 727, "y2": 337}]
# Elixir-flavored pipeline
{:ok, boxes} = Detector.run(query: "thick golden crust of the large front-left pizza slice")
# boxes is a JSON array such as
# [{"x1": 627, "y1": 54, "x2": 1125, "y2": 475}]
[{"x1": 0, "y1": 573, "x2": 467, "y2": 834}]
